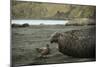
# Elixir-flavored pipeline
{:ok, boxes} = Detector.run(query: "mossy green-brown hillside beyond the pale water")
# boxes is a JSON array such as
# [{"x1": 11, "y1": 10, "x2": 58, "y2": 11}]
[{"x1": 12, "y1": 0, "x2": 96, "y2": 19}]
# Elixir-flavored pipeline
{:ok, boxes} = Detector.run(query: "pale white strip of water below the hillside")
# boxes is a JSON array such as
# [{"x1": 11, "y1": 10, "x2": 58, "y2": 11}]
[{"x1": 11, "y1": 20, "x2": 68, "y2": 25}]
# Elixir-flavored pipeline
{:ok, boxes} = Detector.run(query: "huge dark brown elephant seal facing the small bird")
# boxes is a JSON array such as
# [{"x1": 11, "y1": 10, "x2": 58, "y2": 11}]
[{"x1": 51, "y1": 28, "x2": 95, "y2": 58}]
